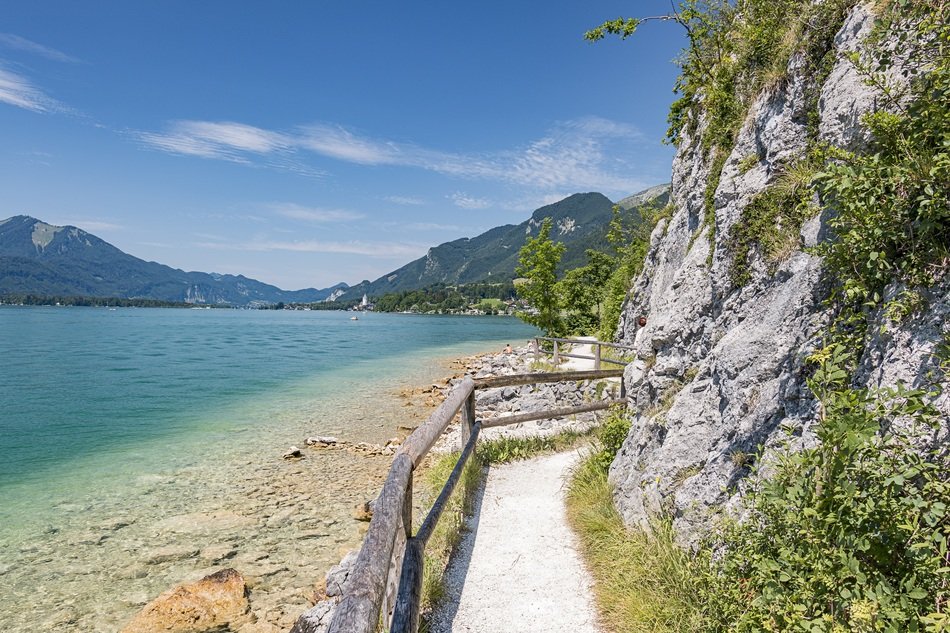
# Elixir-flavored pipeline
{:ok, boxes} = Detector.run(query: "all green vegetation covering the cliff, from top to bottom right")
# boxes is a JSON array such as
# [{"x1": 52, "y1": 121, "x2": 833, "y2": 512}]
[{"x1": 588, "y1": 0, "x2": 950, "y2": 633}]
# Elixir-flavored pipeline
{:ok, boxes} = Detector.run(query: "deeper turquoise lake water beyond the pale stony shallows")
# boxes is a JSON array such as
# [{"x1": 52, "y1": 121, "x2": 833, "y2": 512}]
[{"x1": 0, "y1": 306, "x2": 534, "y2": 498}]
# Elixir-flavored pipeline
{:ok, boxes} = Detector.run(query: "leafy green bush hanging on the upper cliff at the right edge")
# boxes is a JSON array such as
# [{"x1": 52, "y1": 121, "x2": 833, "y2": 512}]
[{"x1": 817, "y1": 34, "x2": 950, "y2": 314}]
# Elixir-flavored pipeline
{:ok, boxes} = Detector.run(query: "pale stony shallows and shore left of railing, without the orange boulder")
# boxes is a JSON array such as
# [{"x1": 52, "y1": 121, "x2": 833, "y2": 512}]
[{"x1": 0, "y1": 346, "x2": 520, "y2": 633}]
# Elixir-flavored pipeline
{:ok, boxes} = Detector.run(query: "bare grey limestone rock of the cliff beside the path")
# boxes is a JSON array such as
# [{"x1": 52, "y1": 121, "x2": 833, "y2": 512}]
[{"x1": 610, "y1": 6, "x2": 950, "y2": 543}]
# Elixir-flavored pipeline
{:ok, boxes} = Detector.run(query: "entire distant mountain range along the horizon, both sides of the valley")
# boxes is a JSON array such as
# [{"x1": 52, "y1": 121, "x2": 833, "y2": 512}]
[{"x1": 0, "y1": 185, "x2": 669, "y2": 306}]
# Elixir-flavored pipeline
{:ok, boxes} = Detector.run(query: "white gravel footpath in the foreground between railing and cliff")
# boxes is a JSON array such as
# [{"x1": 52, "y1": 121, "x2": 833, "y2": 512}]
[{"x1": 431, "y1": 452, "x2": 600, "y2": 633}]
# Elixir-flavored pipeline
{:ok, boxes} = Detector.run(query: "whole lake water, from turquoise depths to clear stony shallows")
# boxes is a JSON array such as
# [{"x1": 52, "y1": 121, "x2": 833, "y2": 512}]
[{"x1": 0, "y1": 306, "x2": 534, "y2": 631}]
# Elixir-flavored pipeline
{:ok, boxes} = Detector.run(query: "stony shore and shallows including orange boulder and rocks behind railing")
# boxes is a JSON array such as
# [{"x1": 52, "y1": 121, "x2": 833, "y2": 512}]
[{"x1": 9, "y1": 347, "x2": 611, "y2": 633}]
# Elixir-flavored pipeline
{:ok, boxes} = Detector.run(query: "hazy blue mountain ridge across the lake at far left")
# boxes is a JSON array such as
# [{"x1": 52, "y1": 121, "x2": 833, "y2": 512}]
[{"x1": 0, "y1": 215, "x2": 348, "y2": 306}]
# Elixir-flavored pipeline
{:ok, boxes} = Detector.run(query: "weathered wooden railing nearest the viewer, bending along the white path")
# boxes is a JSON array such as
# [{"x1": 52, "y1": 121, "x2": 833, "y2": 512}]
[{"x1": 329, "y1": 368, "x2": 626, "y2": 633}]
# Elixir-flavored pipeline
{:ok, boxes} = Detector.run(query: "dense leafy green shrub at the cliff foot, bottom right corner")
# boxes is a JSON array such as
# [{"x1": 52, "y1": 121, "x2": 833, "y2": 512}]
[{"x1": 698, "y1": 346, "x2": 950, "y2": 632}]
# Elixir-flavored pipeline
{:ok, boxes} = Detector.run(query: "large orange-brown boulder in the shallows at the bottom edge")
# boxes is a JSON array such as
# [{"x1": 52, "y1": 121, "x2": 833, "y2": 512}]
[{"x1": 121, "y1": 569, "x2": 249, "y2": 633}]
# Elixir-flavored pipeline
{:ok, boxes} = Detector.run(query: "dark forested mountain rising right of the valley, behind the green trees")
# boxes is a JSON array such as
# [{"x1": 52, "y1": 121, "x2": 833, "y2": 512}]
[{"x1": 342, "y1": 185, "x2": 669, "y2": 300}]
